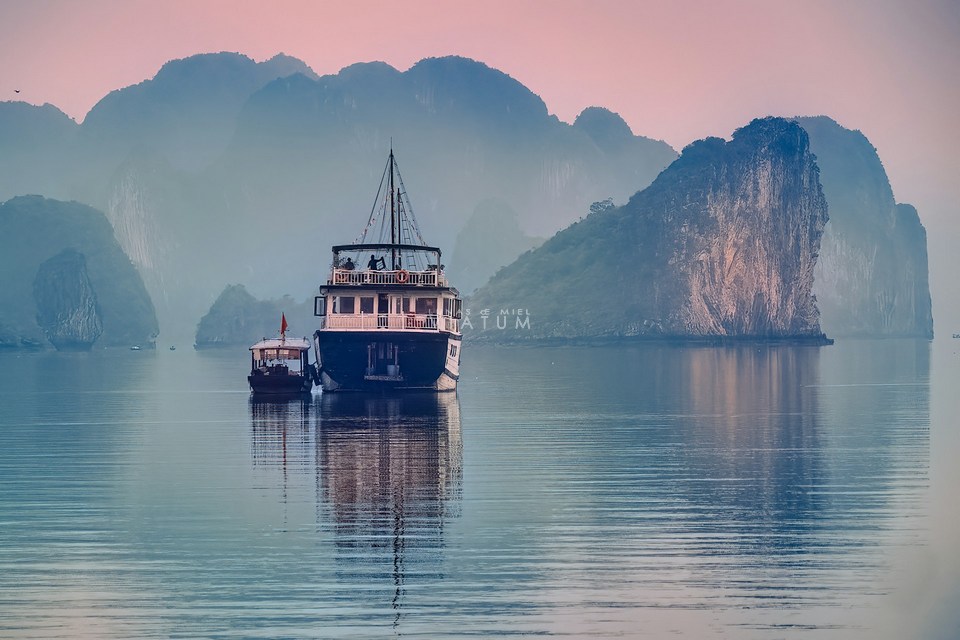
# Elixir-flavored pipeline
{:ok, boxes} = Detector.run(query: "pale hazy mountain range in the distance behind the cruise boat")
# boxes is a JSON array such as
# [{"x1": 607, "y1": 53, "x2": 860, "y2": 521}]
[{"x1": 0, "y1": 53, "x2": 676, "y2": 338}]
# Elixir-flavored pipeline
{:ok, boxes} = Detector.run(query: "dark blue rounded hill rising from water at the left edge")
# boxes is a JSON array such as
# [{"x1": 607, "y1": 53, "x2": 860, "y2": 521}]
[{"x1": 0, "y1": 196, "x2": 158, "y2": 348}]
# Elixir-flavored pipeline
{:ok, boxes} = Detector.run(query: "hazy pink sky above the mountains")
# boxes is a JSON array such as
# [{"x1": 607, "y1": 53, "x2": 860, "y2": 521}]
[{"x1": 0, "y1": 0, "x2": 960, "y2": 324}]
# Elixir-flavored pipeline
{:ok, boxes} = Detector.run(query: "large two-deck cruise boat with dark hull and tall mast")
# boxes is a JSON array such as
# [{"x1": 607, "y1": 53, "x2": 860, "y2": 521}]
[{"x1": 314, "y1": 149, "x2": 462, "y2": 392}]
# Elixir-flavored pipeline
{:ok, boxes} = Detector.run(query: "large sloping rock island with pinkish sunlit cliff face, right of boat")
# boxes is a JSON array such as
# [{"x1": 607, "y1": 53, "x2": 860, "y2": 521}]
[{"x1": 465, "y1": 118, "x2": 828, "y2": 340}]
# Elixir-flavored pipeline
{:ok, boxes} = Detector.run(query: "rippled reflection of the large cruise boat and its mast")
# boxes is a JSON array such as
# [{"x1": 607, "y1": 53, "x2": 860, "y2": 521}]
[{"x1": 318, "y1": 392, "x2": 463, "y2": 625}]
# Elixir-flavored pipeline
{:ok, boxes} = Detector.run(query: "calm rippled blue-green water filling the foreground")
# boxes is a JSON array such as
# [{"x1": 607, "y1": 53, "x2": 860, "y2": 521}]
[{"x1": 0, "y1": 339, "x2": 960, "y2": 638}]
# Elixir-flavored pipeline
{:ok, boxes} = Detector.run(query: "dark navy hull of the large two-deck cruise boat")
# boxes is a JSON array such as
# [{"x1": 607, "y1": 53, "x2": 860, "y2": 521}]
[{"x1": 315, "y1": 330, "x2": 459, "y2": 391}]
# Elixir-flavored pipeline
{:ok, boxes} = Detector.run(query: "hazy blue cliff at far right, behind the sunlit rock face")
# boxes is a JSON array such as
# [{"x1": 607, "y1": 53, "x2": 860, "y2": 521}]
[{"x1": 797, "y1": 116, "x2": 933, "y2": 338}]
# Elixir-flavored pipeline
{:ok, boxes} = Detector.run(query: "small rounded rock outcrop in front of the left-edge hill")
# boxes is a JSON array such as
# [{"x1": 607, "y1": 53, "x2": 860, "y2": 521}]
[{"x1": 33, "y1": 249, "x2": 103, "y2": 351}]
